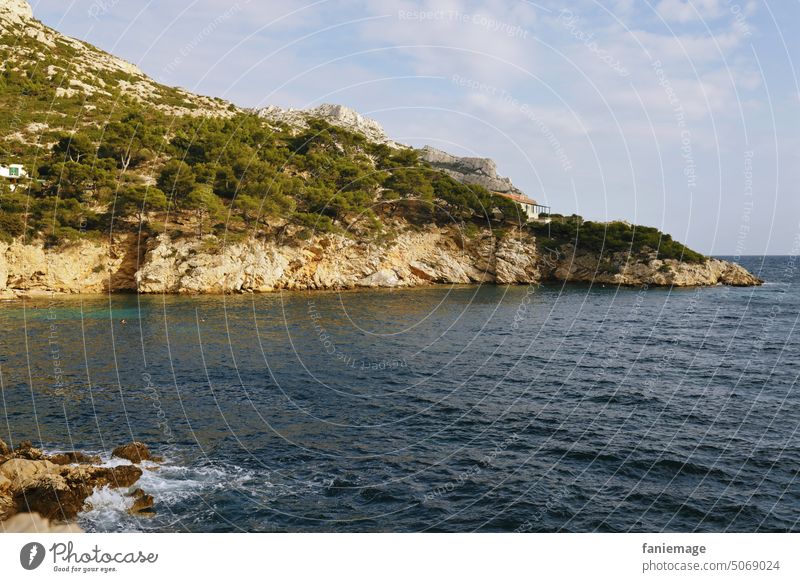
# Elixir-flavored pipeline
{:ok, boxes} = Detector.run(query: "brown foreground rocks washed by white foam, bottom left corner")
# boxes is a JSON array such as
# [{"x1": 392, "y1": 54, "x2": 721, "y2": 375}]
[{"x1": 0, "y1": 440, "x2": 160, "y2": 531}]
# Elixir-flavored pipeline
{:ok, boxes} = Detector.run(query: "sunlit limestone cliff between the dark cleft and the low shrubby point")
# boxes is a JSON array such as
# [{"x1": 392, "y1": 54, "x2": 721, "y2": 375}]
[{"x1": 136, "y1": 226, "x2": 537, "y2": 293}]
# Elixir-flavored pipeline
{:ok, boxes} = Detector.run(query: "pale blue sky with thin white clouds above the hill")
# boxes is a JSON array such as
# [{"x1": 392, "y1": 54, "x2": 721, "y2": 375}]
[{"x1": 30, "y1": 0, "x2": 800, "y2": 255}]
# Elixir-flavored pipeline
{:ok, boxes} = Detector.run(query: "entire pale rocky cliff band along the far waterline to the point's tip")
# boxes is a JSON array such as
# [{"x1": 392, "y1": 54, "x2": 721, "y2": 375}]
[{"x1": 0, "y1": 225, "x2": 762, "y2": 299}]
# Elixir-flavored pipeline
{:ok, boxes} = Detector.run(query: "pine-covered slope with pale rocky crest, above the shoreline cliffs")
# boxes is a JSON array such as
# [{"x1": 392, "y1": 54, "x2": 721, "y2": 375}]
[{"x1": 0, "y1": 0, "x2": 517, "y2": 244}]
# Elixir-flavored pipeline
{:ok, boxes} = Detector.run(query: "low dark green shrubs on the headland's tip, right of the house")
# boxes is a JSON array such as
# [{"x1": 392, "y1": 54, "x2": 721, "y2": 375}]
[{"x1": 529, "y1": 214, "x2": 706, "y2": 264}]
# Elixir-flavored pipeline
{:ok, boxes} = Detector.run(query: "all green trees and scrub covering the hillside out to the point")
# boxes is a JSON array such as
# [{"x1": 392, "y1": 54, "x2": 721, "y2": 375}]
[{"x1": 0, "y1": 22, "x2": 703, "y2": 269}]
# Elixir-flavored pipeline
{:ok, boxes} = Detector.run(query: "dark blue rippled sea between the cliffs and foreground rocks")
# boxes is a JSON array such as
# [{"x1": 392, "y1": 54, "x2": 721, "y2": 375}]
[{"x1": 0, "y1": 257, "x2": 800, "y2": 532}]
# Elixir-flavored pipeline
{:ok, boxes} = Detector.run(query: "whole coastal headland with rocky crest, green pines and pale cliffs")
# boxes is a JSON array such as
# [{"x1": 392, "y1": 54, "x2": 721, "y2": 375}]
[{"x1": 0, "y1": 0, "x2": 755, "y2": 294}]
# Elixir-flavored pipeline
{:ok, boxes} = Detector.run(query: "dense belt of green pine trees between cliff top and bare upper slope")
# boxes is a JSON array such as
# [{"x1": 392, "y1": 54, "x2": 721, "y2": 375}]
[{"x1": 0, "y1": 69, "x2": 521, "y2": 244}]
